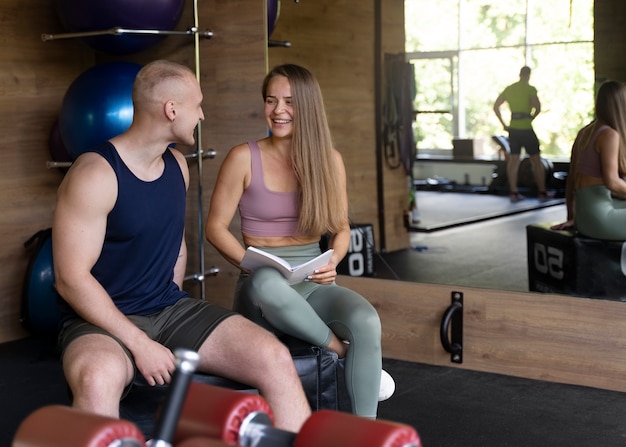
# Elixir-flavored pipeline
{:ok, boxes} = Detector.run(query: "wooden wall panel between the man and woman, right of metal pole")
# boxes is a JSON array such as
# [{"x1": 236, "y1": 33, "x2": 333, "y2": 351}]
[{"x1": 187, "y1": 0, "x2": 267, "y2": 307}]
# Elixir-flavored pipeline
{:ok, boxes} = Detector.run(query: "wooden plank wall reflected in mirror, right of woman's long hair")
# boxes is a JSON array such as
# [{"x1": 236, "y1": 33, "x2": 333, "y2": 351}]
[{"x1": 269, "y1": 0, "x2": 409, "y2": 251}]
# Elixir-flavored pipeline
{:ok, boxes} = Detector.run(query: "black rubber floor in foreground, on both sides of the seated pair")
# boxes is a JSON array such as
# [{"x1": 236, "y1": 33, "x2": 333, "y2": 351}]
[{"x1": 0, "y1": 338, "x2": 626, "y2": 447}]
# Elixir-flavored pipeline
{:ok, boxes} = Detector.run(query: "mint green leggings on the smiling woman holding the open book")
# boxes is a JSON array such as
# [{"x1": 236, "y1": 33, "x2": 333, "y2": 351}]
[{"x1": 234, "y1": 244, "x2": 382, "y2": 418}]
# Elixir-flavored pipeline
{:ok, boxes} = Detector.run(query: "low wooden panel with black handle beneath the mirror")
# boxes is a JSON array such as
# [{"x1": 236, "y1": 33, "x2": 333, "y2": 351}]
[{"x1": 338, "y1": 277, "x2": 626, "y2": 391}]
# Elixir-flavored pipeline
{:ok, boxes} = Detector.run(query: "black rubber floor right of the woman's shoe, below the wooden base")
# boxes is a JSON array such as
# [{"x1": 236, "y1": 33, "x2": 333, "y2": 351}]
[{"x1": 379, "y1": 360, "x2": 626, "y2": 447}]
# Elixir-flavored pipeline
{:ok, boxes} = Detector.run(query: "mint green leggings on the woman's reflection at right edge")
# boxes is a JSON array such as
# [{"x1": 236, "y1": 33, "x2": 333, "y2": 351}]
[{"x1": 574, "y1": 185, "x2": 626, "y2": 241}]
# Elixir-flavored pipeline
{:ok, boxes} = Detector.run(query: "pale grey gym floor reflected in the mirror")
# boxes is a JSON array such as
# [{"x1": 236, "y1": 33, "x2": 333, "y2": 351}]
[{"x1": 375, "y1": 192, "x2": 567, "y2": 292}]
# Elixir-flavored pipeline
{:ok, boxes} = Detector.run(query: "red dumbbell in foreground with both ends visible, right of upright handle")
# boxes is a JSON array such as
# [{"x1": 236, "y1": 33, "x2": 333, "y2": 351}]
[{"x1": 175, "y1": 383, "x2": 421, "y2": 447}]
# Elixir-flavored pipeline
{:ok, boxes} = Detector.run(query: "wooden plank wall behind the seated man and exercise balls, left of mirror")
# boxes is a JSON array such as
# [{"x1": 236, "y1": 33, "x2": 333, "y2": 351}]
[{"x1": 0, "y1": 0, "x2": 267, "y2": 342}]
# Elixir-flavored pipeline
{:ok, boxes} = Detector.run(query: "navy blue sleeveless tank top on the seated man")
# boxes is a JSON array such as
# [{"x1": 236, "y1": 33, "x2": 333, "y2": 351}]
[{"x1": 87, "y1": 142, "x2": 188, "y2": 315}]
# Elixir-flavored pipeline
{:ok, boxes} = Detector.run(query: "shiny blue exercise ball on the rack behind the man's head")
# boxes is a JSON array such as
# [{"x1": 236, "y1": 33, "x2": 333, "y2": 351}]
[{"x1": 59, "y1": 61, "x2": 141, "y2": 160}]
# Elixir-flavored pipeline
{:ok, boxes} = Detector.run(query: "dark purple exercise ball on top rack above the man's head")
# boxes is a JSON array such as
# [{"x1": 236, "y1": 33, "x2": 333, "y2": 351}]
[{"x1": 56, "y1": 0, "x2": 185, "y2": 55}]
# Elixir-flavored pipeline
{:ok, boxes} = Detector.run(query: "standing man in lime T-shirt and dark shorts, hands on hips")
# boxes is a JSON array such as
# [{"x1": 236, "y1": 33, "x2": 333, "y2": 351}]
[{"x1": 493, "y1": 66, "x2": 548, "y2": 203}]
